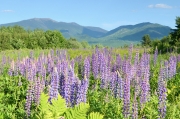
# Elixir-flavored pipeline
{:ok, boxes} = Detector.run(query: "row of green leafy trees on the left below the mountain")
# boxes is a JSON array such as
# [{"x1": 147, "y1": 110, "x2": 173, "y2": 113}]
[{"x1": 0, "y1": 26, "x2": 101, "y2": 51}]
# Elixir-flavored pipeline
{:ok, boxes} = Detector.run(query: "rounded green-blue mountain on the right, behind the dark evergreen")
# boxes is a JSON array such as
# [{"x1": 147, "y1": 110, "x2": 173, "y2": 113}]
[{"x1": 103, "y1": 22, "x2": 171, "y2": 41}]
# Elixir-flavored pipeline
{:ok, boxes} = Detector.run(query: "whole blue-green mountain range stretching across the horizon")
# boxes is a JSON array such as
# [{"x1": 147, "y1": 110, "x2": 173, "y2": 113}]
[{"x1": 0, "y1": 18, "x2": 171, "y2": 47}]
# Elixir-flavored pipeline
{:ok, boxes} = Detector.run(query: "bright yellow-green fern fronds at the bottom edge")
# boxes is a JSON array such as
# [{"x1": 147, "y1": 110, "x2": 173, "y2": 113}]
[{"x1": 35, "y1": 93, "x2": 103, "y2": 119}]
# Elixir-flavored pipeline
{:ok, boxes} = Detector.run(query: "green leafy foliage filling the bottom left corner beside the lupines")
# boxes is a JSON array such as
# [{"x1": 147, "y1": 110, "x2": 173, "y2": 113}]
[{"x1": 0, "y1": 74, "x2": 28, "y2": 119}]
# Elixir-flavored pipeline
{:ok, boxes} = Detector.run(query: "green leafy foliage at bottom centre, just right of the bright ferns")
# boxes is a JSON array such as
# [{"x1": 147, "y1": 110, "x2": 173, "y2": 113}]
[{"x1": 88, "y1": 87, "x2": 123, "y2": 119}]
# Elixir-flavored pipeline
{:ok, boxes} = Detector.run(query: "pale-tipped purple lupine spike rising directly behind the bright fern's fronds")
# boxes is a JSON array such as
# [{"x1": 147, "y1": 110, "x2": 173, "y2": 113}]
[{"x1": 49, "y1": 67, "x2": 59, "y2": 100}]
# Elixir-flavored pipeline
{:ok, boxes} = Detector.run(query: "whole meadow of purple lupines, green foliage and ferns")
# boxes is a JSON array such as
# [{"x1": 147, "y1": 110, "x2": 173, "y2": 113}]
[{"x1": 0, "y1": 45, "x2": 180, "y2": 119}]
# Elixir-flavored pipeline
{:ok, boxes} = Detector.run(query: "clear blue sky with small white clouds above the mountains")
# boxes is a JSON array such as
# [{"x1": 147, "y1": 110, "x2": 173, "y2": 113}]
[{"x1": 0, "y1": 0, "x2": 180, "y2": 30}]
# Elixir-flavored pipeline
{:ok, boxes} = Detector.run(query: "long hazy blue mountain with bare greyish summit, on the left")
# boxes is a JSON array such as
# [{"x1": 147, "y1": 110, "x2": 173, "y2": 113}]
[{"x1": 0, "y1": 18, "x2": 107, "y2": 38}]
